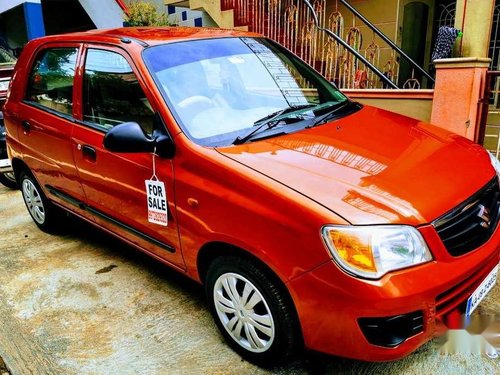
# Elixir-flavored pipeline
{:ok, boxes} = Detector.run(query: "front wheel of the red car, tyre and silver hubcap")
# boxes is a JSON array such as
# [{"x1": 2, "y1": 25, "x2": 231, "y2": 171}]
[{"x1": 205, "y1": 257, "x2": 300, "y2": 365}]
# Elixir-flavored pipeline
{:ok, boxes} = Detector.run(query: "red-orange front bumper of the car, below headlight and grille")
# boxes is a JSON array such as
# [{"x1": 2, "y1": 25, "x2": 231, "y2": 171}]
[{"x1": 288, "y1": 223, "x2": 500, "y2": 361}]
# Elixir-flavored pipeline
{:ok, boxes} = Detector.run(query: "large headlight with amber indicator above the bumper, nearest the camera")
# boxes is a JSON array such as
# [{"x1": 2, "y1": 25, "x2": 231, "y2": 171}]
[{"x1": 322, "y1": 225, "x2": 432, "y2": 279}]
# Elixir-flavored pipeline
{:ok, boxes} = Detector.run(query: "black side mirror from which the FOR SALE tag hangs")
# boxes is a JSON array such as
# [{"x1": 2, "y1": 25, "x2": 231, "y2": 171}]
[{"x1": 104, "y1": 122, "x2": 155, "y2": 152}]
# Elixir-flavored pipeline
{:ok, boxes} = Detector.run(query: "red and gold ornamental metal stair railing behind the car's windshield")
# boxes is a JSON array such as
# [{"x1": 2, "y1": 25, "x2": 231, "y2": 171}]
[{"x1": 221, "y1": 0, "x2": 433, "y2": 89}]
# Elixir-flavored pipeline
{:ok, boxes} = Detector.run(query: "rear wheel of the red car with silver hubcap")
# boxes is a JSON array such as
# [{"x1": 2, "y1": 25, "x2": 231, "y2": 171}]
[{"x1": 19, "y1": 171, "x2": 61, "y2": 233}]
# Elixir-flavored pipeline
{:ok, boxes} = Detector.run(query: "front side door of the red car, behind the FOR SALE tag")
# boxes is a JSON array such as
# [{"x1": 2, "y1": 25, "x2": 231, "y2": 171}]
[{"x1": 73, "y1": 46, "x2": 184, "y2": 268}]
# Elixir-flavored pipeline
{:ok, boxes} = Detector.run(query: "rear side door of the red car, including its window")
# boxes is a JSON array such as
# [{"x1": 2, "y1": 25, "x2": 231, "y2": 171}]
[{"x1": 13, "y1": 43, "x2": 91, "y2": 217}]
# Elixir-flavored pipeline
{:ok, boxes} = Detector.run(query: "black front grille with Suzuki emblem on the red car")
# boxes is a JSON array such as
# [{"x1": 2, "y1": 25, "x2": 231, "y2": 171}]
[{"x1": 432, "y1": 176, "x2": 500, "y2": 256}]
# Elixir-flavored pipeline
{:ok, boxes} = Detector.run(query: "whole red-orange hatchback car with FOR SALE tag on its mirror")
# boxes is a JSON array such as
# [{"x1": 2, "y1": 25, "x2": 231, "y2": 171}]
[{"x1": 5, "y1": 28, "x2": 500, "y2": 363}]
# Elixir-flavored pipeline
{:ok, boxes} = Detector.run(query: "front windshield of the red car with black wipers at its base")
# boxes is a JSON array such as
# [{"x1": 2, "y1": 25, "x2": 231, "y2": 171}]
[{"x1": 143, "y1": 38, "x2": 347, "y2": 146}]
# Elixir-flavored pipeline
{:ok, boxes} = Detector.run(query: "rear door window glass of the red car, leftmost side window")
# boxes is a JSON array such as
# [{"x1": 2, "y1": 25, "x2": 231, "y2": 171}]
[{"x1": 26, "y1": 48, "x2": 78, "y2": 116}]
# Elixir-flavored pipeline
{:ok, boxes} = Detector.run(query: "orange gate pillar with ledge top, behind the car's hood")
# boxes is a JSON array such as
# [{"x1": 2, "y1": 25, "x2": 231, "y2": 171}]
[{"x1": 431, "y1": 57, "x2": 491, "y2": 141}]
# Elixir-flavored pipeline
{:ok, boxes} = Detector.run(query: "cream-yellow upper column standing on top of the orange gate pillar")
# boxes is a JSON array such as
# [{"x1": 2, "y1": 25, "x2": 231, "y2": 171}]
[{"x1": 455, "y1": 0, "x2": 495, "y2": 57}]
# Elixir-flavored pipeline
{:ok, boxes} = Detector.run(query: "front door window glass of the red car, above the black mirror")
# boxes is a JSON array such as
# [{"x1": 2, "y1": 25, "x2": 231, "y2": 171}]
[{"x1": 83, "y1": 49, "x2": 154, "y2": 135}]
